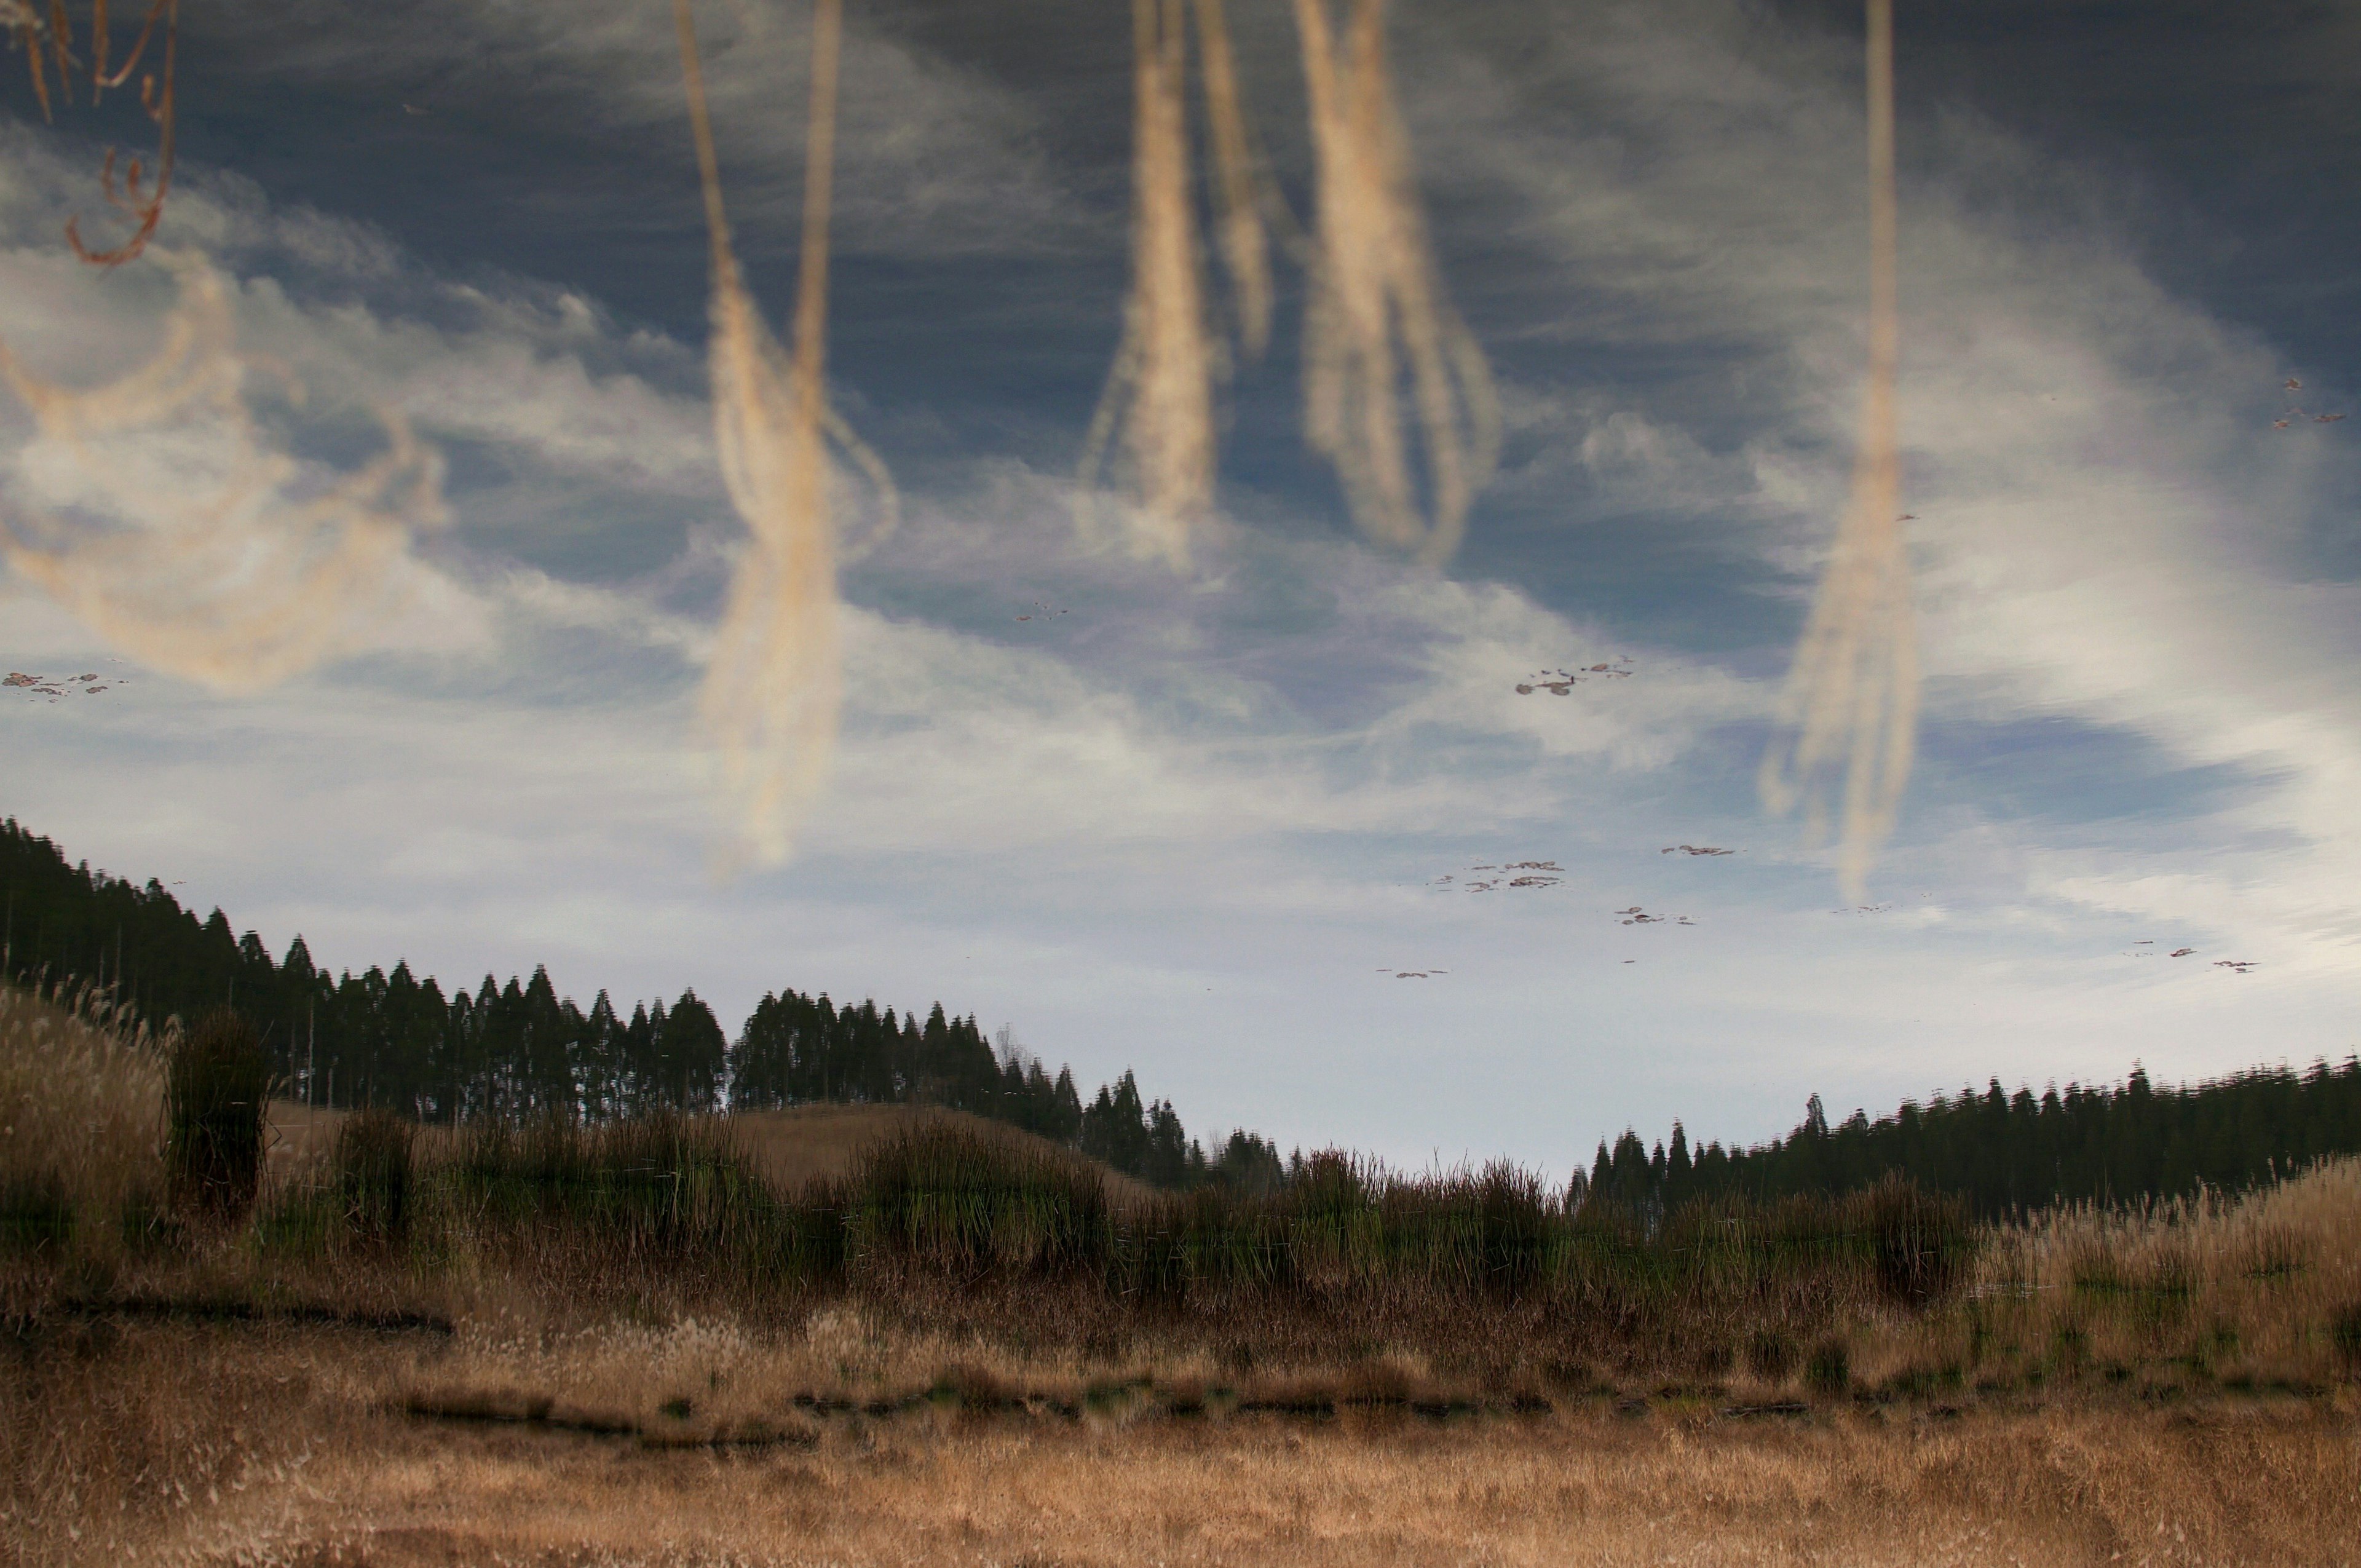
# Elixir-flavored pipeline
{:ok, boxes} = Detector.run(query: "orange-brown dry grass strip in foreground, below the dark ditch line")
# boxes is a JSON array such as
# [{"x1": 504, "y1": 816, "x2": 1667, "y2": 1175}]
[{"x1": 0, "y1": 1324, "x2": 2361, "y2": 1568}]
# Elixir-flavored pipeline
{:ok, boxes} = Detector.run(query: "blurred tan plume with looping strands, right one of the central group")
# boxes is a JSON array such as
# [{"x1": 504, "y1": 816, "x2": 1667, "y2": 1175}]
[{"x1": 1296, "y1": 0, "x2": 1499, "y2": 564}]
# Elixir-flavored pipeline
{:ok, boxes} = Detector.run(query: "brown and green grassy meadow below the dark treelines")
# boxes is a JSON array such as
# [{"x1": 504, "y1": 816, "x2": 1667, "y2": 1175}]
[{"x1": 0, "y1": 992, "x2": 2361, "y2": 1563}]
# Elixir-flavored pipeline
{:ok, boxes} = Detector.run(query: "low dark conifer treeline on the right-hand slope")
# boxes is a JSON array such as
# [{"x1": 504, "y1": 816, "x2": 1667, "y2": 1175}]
[{"x1": 1577, "y1": 1056, "x2": 2361, "y2": 1219}]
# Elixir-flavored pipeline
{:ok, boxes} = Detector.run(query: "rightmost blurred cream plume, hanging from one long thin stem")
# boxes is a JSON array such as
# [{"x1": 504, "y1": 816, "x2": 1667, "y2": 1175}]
[{"x1": 1759, "y1": 0, "x2": 1920, "y2": 897}]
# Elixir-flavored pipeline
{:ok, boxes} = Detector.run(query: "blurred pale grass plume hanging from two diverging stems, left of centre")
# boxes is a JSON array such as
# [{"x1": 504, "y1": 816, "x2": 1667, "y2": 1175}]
[{"x1": 673, "y1": 0, "x2": 895, "y2": 865}]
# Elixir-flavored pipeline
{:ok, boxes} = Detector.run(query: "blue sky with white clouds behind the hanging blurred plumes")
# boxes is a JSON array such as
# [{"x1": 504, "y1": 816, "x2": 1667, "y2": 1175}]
[{"x1": 0, "y1": 0, "x2": 2361, "y2": 1174}]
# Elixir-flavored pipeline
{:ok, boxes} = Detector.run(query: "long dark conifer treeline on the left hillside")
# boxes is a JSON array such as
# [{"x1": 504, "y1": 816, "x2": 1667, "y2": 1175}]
[{"x1": 0, "y1": 820, "x2": 1279, "y2": 1188}]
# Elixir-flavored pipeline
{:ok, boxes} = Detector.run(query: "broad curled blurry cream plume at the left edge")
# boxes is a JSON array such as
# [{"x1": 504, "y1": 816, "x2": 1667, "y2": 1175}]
[{"x1": 0, "y1": 250, "x2": 444, "y2": 689}]
